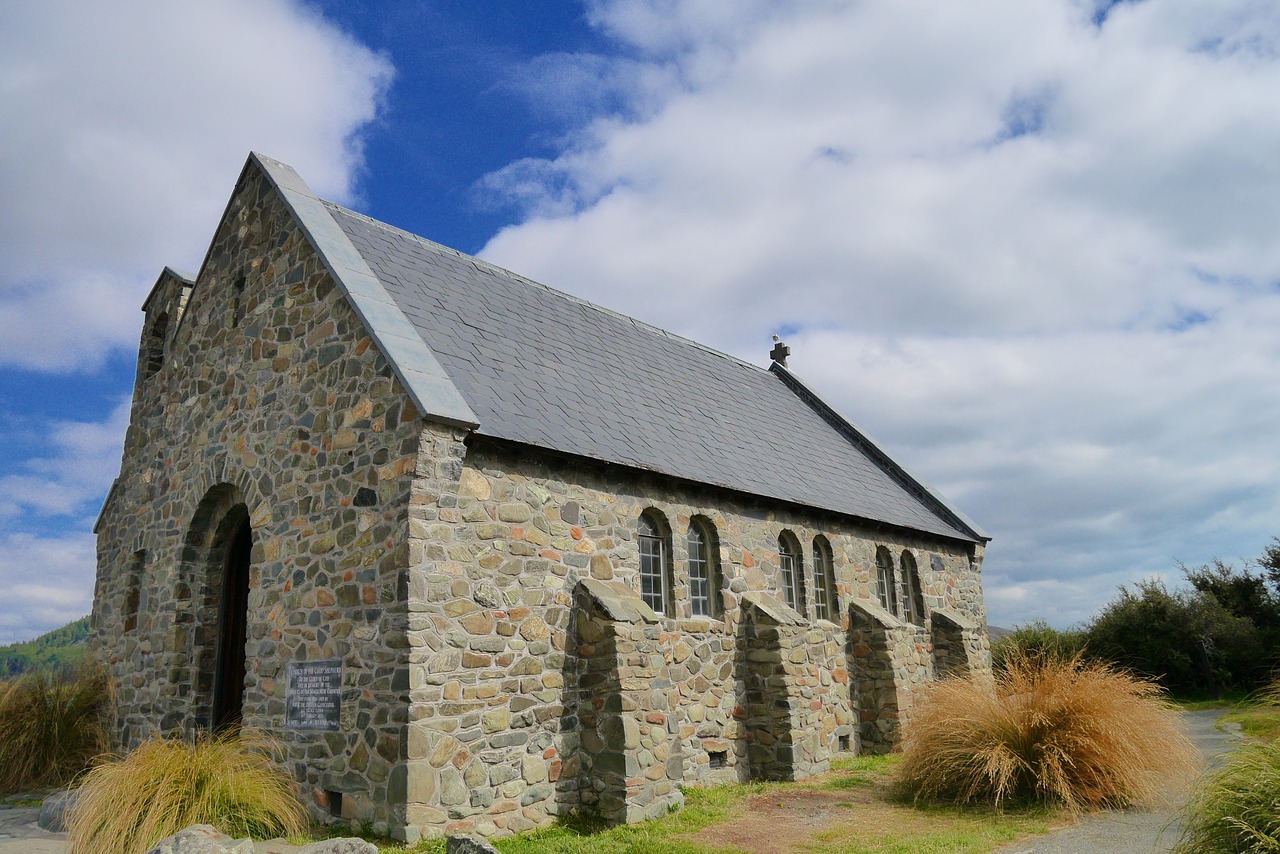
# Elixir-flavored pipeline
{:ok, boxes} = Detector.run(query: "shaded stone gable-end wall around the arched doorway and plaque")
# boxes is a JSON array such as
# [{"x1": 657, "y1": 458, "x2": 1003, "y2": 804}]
[{"x1": 92, "y1": 160, "x2": 421, "y2": 830}]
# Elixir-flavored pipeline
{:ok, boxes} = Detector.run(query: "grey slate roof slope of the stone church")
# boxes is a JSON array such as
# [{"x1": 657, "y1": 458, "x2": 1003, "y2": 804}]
[{"x1": 325, "y1": 202, "x2": 984, "y2": 540}]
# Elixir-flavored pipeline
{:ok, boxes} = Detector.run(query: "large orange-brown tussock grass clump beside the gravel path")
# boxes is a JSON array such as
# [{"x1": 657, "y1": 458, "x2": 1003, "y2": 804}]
[{"x1": 899, "y1": 656, "x2": 1199, "y2": 810}]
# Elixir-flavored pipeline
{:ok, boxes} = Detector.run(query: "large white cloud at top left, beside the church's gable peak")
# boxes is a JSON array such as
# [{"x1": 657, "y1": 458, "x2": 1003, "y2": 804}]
[{"x1": 0, "y1": 0, "x2": 390, "y2": 369}]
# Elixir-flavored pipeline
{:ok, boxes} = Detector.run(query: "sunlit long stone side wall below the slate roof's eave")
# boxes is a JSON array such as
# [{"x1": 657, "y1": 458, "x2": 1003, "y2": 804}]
[{"x1": 408, "y1": 440, "x2": 983, "y2": 836}]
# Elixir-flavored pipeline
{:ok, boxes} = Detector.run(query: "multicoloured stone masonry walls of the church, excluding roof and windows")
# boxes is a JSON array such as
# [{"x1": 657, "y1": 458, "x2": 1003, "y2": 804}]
[{"x1": 92, "y1": 151, "x2": 989, "y2": 841}]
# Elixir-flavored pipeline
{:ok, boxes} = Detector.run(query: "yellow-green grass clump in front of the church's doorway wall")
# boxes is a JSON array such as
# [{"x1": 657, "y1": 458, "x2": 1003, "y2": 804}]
[{"x1": 67, "y1": 734, "x2": 308, "y2": 854}]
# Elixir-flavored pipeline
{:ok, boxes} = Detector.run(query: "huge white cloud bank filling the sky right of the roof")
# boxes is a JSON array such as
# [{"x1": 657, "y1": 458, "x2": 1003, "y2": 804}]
[{"x1": 483, "y1": 0, "x2": 1280, "y2": 624}]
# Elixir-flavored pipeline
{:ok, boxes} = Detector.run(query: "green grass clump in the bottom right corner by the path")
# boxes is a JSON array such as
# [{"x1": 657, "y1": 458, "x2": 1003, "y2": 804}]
[{"x1": 1174, "y1": 739, "x2": 1280, "y2": 854}]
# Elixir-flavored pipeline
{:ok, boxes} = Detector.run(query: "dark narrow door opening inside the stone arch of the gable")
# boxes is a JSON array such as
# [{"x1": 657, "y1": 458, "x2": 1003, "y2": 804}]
[{"x1": 210, "y1": 515, "x2": 253, "y2": 730}]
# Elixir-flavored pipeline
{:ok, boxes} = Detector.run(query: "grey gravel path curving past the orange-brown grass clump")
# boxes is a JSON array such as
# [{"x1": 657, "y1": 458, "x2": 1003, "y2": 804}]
[{"x1": 998, "y1": 711, "x2": 1240, "y2": 854}]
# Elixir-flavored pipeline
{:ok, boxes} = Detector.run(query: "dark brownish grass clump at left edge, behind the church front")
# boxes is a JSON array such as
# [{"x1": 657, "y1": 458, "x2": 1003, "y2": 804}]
[{"x1": 0, "y1": 665, "x2": 110, "y2": 794}]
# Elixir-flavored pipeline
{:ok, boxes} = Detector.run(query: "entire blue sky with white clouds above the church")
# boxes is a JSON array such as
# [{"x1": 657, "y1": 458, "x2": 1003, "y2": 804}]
[{"x1": 0, "y1": 0, "x2": 1280, "y2": 643}]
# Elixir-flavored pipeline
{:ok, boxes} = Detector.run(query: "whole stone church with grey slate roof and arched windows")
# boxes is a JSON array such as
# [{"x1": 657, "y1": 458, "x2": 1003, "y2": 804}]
[{"x1": 92, "y1": 154, "x2": 989, "y2": 841}]
